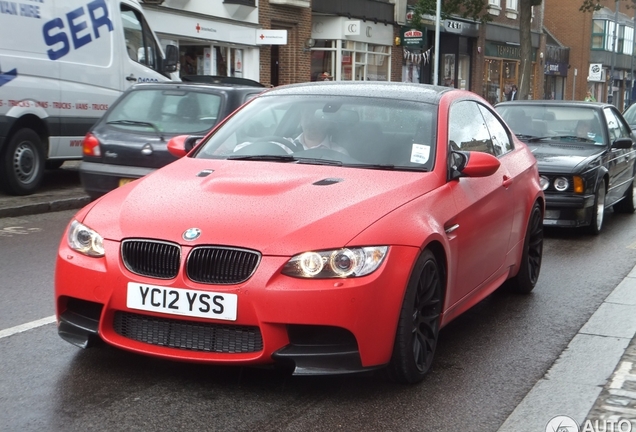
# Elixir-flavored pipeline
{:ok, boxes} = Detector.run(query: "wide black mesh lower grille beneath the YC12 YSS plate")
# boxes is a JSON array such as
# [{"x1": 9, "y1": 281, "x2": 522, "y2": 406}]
[{"x1": 113, "y1": 312, "x2": 263, "y2": 354}]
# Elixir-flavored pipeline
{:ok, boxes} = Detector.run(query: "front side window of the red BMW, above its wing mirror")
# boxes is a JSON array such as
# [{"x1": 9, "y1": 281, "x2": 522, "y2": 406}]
[{"x1": 448, "y1": 101, "x2": 496, "y2": 155}]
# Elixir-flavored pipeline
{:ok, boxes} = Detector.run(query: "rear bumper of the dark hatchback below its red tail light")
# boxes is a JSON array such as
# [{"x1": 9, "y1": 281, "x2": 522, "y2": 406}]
[{"x1": 79, "y1": 161, "x2": 156, "y2": 199}]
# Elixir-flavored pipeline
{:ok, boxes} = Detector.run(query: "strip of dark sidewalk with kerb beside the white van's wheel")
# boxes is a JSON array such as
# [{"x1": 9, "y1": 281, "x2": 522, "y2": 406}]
[{"x1": 0, "y1": 161, "x2": 90, "y2": 218}]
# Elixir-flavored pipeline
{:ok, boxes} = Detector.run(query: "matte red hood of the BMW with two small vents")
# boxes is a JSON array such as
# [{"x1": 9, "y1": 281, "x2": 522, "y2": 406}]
[{"x1": 82, "y1": 157, "x2": 443, "y2": 255}]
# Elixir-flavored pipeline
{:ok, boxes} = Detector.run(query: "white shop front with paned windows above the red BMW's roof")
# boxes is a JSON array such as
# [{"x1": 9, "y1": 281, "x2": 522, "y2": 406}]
[{"x1": 310, "y1": 15, "x2": 393, "y2": 81}]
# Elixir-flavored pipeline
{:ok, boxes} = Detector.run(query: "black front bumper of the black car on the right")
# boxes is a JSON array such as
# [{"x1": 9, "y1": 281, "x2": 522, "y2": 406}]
[{"x1": 543, "y1": 193, "x2": 594, "y2": 228}]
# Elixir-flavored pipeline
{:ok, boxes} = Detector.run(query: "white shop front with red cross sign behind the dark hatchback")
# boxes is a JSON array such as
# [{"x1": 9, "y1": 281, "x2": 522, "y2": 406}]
[{"x1": 144, "y1": 6, "x2": 259, "y2": 81}]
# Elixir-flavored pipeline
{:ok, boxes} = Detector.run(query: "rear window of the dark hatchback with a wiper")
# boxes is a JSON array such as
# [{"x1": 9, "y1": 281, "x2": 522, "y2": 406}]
[{"x1": 104, "y1": 89, "x2": 221, "y2": 135}]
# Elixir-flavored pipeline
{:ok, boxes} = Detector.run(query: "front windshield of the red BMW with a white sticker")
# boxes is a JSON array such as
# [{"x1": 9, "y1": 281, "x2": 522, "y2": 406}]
[{"x1": 195, "y1": 94, "x2": 436, "y2": 171}]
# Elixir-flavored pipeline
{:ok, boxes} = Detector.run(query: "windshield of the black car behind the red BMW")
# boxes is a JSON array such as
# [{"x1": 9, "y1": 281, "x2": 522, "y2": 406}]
[{"x1": 496, "y1": 104, "x2": 606, "y2": 145}]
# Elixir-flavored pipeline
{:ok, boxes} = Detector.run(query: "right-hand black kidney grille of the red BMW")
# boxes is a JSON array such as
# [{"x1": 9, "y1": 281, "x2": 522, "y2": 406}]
[{"x1": 186, "y1": 246, "x2": 260, "y2": 284}]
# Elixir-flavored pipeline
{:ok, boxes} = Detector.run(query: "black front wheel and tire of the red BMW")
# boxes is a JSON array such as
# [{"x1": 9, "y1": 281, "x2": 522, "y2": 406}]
[{"x1": 388, "y1": 249, "x2": 444, "y2": 384}]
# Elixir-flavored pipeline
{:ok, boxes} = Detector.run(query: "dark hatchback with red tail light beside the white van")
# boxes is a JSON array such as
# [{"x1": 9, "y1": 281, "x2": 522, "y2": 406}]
[{"x1": 79, "y1": 82, "x2": 265, "y2": 199}]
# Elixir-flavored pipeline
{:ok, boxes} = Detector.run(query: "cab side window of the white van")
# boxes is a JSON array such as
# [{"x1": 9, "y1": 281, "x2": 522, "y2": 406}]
[{"x1": 121, "y1": 4, "x2": 159, "y2": 70}]
